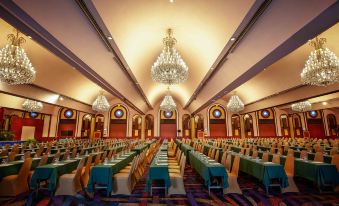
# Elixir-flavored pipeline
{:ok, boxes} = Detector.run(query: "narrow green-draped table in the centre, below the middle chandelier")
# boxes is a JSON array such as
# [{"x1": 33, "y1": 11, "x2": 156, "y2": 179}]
[{"x1": 145, "y1": 152, "x2": 171, "y2": 192}]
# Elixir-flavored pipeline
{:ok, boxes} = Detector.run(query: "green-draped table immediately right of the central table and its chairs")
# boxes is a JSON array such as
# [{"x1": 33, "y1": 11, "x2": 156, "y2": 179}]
[{"x1": 189, "y1": 152, "x2": 228, "y2": 188}]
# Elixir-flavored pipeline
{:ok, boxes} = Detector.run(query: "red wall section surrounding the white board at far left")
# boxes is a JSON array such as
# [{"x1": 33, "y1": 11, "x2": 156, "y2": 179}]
[{"x1": 11, "y1": 116, "x2": 44, "y2": 140}]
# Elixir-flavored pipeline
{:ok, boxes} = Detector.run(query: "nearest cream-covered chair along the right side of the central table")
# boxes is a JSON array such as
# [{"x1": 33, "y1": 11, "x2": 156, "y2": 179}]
[{"x1": 168, "y1": 155, "x2": 186, "y2": 195}]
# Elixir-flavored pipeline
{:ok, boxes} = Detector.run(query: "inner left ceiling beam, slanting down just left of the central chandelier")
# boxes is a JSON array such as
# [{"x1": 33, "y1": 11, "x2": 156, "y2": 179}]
[{"x1": 75, "y1": 0, "x2": 152, "y2": 109}]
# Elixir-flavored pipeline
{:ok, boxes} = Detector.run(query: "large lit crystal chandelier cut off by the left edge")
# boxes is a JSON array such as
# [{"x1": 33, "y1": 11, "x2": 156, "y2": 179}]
[{"x1": 0, "y1": 30, "x2": 35, "y2": 85}]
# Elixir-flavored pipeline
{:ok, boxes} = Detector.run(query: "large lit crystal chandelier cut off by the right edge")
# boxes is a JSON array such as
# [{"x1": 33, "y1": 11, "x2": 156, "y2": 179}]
[{"x1": 300, "y1": 37, "x2": 339, "y2": 86}]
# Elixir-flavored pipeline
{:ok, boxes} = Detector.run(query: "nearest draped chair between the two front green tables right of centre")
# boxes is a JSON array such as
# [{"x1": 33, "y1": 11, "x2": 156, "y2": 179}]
[{"x1": 224, "y1": 155, "x2": 242, "y2": 194}]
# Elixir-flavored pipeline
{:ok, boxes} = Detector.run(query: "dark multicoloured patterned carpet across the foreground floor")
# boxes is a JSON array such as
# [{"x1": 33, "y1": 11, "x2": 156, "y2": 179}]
[{"x1": 0, "y1": 165, "x2": 339, "y2": 206}]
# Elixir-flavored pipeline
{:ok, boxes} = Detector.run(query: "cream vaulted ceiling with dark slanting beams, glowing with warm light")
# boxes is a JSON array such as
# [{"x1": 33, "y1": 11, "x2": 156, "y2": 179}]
[{"x1": 0, "y1": 0, "x2": 339, "y2": 113}]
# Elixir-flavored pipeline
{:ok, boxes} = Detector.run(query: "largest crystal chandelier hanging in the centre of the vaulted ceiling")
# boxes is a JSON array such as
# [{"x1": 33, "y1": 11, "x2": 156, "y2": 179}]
[{"x1": 151, "y1": 29, "x2": 188, "y2": 85}]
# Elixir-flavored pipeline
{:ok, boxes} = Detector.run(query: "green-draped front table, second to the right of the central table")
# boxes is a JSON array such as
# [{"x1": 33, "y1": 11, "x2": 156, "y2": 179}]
[{"x1": 231, "y1": 153, "x2": 288, "y2": 191}]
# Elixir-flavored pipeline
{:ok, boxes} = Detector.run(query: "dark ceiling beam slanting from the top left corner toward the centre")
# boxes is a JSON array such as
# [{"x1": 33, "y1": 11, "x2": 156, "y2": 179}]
[{"x1": 0, "y1": 1, "x2": 144, "y2": 114}]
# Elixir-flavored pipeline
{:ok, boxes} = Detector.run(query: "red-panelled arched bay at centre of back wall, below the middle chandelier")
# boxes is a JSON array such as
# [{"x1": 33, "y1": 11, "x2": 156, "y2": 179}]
[{"x1": 159, "y1": 110, "x2": 177, "y2": 138}]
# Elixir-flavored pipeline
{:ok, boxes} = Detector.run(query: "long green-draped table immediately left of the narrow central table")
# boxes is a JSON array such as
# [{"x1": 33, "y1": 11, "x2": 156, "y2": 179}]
[{"x1": 87, "y1": 152, "x2": 136, "y2": 195}]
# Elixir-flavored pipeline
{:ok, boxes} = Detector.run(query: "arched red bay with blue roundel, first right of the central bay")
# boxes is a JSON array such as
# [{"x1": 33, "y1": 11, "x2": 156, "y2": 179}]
[{"x1": 208, "y1": 104, "x2": 227, "y2": 137}]
